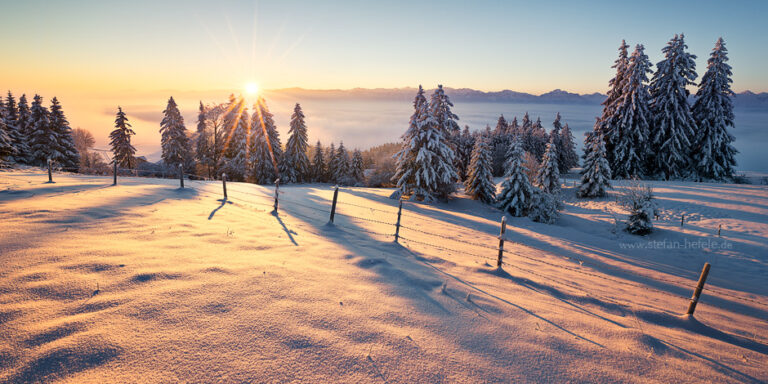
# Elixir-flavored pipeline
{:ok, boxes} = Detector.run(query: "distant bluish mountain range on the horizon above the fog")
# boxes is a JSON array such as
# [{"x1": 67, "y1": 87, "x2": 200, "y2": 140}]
[{"x1": 269, "y1": 87, "x2": 768, "y2": 109}]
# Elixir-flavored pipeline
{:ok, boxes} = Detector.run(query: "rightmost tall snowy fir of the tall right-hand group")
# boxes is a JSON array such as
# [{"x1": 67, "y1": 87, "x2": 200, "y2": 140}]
[{"x1": 693, "y1": 37, "x2": 738, "y2": 181}]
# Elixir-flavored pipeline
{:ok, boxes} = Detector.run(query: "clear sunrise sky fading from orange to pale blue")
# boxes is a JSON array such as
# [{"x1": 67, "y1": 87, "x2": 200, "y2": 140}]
[{"x1": 0, "y1": 0, "x2": 768, "y2": 158}]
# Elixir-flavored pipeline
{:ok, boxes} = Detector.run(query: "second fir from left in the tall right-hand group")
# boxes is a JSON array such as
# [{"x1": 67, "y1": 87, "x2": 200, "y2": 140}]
[{"x1": 606, "y1": 44, "x2": 652, "y2": 179}]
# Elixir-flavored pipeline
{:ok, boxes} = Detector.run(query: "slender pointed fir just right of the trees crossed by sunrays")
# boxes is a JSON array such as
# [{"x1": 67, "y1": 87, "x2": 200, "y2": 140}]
[{"x1": 281, "y1": 103, "x2": 312, "y2": 183}]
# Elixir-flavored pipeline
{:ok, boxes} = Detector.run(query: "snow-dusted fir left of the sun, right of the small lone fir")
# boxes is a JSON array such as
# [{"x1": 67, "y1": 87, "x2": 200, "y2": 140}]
[{"x1": 160, "y1": 97, "x2": 190, "y2": 168}]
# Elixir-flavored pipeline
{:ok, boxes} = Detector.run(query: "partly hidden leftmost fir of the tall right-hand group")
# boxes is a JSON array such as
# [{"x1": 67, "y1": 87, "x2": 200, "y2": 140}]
[{"x1": 600, "y1": 40, "x2": 629, "y2": 170}]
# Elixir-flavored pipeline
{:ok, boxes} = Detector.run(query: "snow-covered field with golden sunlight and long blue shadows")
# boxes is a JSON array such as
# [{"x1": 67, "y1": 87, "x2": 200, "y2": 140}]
[{"x1": 0, "y1": 170, "x2": 768, "y2": 383}]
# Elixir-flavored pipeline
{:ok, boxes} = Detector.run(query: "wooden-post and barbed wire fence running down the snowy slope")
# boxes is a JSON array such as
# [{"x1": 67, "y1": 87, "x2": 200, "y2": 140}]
[{"x1": 21, "y1": 166, "x2": 768, "y2": 332}]
